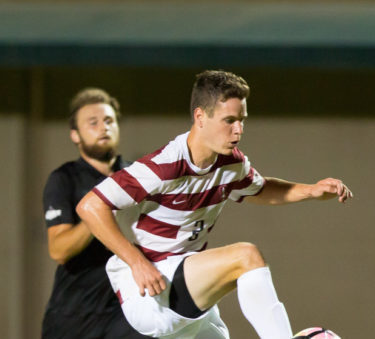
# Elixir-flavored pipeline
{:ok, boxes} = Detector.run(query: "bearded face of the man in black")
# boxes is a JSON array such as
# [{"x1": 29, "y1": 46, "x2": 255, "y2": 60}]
[{"x1": 77, "y1": 103, "x2": 120, "y2": 160}]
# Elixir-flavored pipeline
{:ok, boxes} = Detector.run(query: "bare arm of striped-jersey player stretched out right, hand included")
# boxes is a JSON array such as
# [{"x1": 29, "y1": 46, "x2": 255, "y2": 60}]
[{"x1": 245, "y1": 177, "x2": 353, "y2": 205}]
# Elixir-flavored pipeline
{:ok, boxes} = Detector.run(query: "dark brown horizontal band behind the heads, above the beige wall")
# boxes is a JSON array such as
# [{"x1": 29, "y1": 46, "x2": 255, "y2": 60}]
[{"x1": 0, "y1": 66, "x2": 375, "y2": 120}]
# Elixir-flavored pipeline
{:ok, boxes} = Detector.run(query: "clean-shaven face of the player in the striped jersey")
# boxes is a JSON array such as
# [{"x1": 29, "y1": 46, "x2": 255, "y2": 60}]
[{"x1": 205, "y1": 98, "x2": 247, "y2": 155}]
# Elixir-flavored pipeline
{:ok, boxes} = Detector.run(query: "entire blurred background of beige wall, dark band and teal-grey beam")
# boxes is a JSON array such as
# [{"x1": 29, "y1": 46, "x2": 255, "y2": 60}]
[{"x1": 0, "y1": 0, "x2": 375, "y2": 339}]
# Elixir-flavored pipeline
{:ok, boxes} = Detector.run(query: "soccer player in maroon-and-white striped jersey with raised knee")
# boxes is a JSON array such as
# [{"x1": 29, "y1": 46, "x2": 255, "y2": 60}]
[{"x1": 77, "y1": 71, "x2": 352, "y2": 339}]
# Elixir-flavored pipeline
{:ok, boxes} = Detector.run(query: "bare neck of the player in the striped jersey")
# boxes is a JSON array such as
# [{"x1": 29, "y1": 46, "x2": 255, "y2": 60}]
[{"x1": 187, "y1": 128, "x2": 217, "y2": 169}]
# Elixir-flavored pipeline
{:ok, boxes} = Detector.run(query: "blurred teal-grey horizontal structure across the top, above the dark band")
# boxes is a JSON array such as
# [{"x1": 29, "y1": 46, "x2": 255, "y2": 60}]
[{"x1": 0, "y1": 1, "x2": 375, "y2": 68}]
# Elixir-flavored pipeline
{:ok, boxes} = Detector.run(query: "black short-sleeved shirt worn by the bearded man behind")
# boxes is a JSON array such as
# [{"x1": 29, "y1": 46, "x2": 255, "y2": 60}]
[{"x1": 43, "y1": 157, "x2": 151, "y2": 338}]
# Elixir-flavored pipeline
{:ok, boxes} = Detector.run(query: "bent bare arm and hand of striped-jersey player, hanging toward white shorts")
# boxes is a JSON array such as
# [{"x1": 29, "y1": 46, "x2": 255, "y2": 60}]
[{"x1": 77, "y1": 192, "x2": 166, "y2": 296}]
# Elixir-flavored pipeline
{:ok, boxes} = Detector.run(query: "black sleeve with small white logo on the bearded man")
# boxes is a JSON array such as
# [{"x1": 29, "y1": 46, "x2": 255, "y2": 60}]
[{"x1": 43, "y1": 171, "x2": 76, "y2": 227}]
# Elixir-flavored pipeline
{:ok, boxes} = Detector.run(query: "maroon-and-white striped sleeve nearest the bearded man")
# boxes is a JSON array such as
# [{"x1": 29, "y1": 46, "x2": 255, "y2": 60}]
[{"x1": 92, "y1": 161, "x2": 162, "y2": 210}]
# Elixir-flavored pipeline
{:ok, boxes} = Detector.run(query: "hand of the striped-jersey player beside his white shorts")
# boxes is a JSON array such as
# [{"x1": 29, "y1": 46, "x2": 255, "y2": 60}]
[{"x1": 131, "y1": 259, "x2": 167, "y2": 297}]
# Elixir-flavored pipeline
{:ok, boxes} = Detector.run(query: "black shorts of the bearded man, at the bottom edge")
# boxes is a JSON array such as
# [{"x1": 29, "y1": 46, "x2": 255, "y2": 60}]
[{"x1": 42, "y1": 310, "x2": 150, "y2": 339}]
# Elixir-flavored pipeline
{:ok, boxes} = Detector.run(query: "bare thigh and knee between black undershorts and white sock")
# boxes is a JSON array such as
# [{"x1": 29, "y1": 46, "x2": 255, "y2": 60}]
[{"x1": 184, "y1": 243, "x2": 265, "y2": 310}]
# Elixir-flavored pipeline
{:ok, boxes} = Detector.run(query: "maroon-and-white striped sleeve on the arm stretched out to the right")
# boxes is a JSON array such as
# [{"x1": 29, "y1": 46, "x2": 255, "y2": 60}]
[{"x1": 229, "y1": 156, "x2": 265, "y2": 202}]
